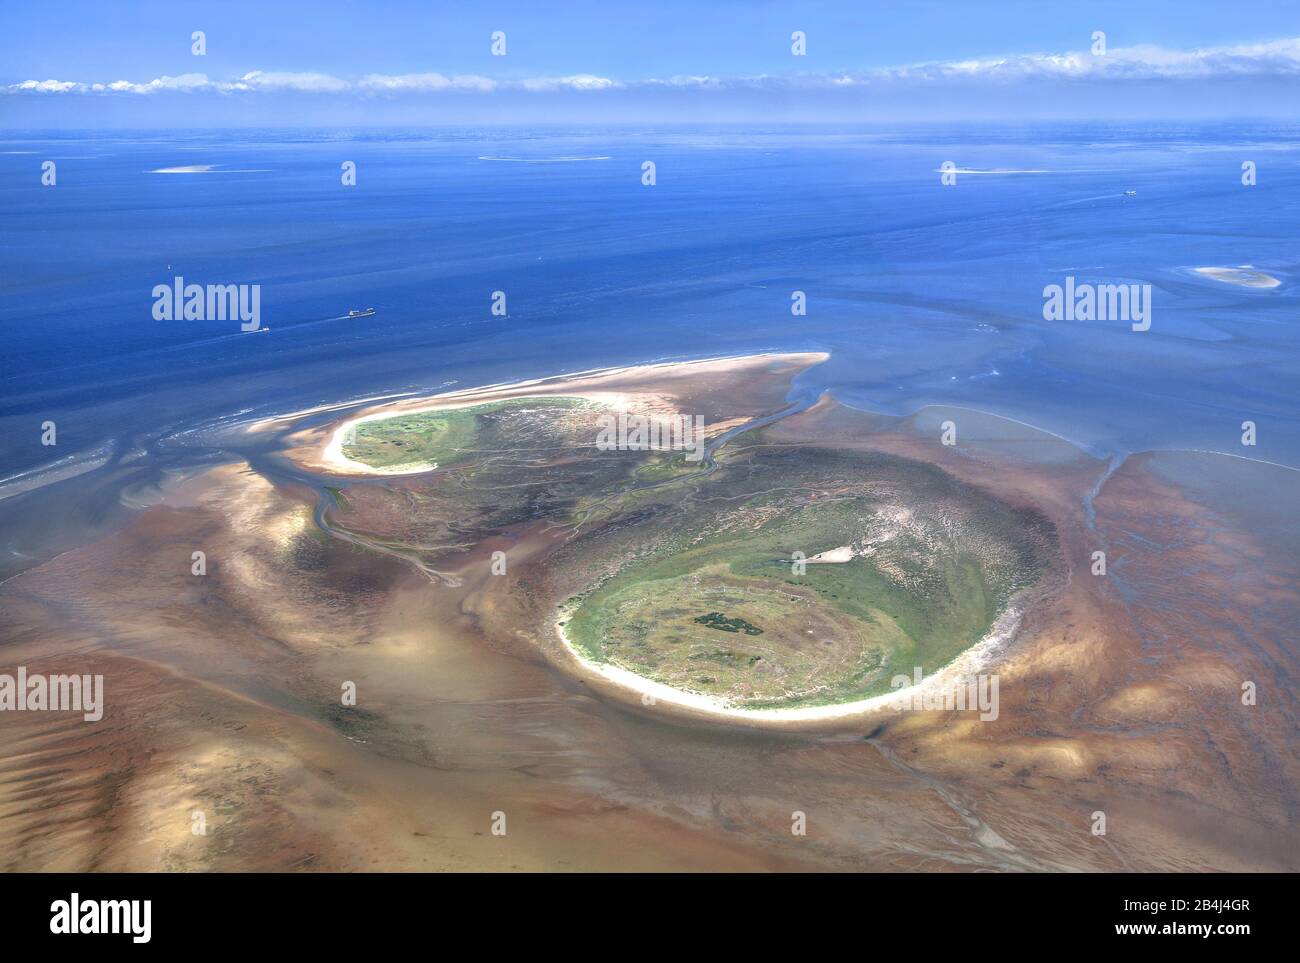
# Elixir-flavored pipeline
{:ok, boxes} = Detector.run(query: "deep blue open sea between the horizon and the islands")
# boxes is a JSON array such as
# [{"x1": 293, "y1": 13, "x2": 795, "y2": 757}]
[{"x1": 0, "y1": 125, "x2": 1300, "y2": 576}]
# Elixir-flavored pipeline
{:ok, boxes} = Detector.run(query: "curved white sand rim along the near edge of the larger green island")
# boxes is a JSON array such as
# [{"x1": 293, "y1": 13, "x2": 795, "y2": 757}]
[{"x1": 553, "y1": 599, "x2": 1023, "y2": 723}]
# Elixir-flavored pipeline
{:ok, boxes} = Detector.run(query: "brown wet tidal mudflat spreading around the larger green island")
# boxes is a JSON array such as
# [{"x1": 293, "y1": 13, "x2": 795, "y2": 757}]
[{"x1": 0, "y1": 359, "x2": 1300, "y2": 872}]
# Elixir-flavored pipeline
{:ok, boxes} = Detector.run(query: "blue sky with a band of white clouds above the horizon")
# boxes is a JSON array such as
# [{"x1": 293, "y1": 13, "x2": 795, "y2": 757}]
[{"x1": 0, "y1": 0, "x2": 1300, "y2": 127}]
